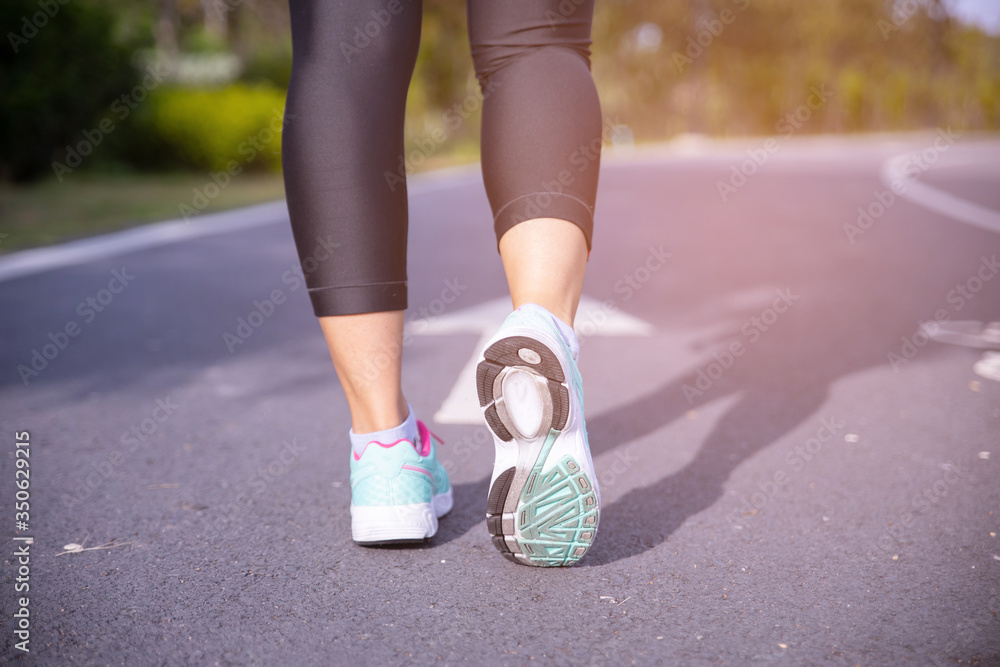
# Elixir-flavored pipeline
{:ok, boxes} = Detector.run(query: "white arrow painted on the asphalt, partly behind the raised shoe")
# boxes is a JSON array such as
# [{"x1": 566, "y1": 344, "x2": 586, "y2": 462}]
[{"x1": 411, "y1": 297, "x2": 653, "y2": 424}]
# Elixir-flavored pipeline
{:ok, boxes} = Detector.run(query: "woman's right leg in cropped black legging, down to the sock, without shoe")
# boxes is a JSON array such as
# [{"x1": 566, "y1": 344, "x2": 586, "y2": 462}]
[{"x1": 469, "y1": 0, "x2": 601, "y2": 325}]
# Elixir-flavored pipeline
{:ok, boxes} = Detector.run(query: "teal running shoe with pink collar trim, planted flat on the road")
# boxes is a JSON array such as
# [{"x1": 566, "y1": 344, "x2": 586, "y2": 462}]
[{"x1": 351, "y1": 420, "x2": 454, "y2": 544}]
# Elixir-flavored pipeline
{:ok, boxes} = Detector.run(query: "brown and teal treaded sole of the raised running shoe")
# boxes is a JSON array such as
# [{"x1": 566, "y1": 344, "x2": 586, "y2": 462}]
[{"x1": 476, "y1": 335, "x2": 599, "y2": 567}]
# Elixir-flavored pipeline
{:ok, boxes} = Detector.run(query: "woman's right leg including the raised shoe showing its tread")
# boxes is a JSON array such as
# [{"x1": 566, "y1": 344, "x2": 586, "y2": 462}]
[{"x1": 469, "y1": 0, "x2": 601, "y2": 566}]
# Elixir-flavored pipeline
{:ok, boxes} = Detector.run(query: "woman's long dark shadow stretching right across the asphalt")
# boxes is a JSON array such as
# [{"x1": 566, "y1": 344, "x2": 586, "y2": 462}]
[{"x1": 581, "y1": 215, "x2": 1000, "y2": 566}]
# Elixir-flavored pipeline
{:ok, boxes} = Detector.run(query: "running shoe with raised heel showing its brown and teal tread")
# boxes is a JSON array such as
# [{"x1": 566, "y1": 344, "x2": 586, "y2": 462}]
[{"x1": 476, "y1": 304, "x2": 601, "y2": 567}]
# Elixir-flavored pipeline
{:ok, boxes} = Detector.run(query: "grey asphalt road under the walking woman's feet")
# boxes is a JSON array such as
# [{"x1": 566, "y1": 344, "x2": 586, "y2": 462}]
[{"x1": 0, "y1": 133, "x2": 1000, "y2": 665}]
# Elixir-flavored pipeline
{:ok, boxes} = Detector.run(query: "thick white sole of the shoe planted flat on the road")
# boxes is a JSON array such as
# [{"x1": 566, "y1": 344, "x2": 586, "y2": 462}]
[{"x1": 351, "y1": 487, "x2": 454, "y2": 546}]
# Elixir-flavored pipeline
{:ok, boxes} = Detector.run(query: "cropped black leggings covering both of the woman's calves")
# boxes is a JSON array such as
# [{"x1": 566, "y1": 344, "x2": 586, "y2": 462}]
[{"x1": 282, "y1": 0, "x2": 601, "y2": 317}]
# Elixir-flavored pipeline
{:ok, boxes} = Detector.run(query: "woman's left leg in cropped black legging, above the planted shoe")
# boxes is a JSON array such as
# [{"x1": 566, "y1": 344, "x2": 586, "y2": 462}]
[{"x1": 282, "y1": 0, "x2": 422, "y2": 433}]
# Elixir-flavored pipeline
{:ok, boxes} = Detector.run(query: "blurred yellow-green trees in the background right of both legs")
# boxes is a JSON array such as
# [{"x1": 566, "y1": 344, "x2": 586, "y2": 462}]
[{"x1": 593, "y1": 0, "x2": 1000, "y2": 140}]
